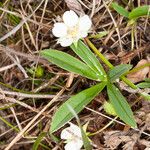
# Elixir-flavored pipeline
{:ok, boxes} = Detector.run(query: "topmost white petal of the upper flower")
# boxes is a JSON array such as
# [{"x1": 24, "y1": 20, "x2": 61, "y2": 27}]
[{"x1": 63, "y1": 10, "x2": 79, "y2": 27}]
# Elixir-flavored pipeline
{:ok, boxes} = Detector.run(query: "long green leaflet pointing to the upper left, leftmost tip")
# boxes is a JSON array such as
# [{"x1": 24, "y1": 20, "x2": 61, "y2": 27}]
[{"x1": 41, "y1": 49, "x2": 100, "y2": 81}]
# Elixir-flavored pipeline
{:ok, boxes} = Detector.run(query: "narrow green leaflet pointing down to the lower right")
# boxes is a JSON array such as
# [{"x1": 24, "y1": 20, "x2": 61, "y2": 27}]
[{"x1": 107, "y1": 83, "x2": 137, "y2": 128}]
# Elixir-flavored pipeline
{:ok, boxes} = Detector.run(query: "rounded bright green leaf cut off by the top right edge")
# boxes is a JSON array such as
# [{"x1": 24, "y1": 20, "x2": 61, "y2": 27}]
[{"x1": 129, "y1": 5, "x2": 150, "y2": 20}]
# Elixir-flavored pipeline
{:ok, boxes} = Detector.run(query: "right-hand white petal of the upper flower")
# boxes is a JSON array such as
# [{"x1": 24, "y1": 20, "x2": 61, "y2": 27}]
[{"x1": 79, "y1": 15, "x2": 92, "y2": 31}]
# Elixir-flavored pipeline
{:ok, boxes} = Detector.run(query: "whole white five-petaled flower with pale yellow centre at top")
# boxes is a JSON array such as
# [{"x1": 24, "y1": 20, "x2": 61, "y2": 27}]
[{"x1": 52, "y1": 10, "x2": 92, "y2": 47}]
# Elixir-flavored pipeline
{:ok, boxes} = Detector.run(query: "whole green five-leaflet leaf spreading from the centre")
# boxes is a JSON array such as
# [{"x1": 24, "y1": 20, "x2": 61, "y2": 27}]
[{"x1": 41, "y1": 41, "x2": 136, "y2": 136}]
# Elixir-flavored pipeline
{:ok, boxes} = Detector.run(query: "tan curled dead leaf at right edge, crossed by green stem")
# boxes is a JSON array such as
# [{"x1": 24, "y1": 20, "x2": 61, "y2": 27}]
[{"x1": 127, "y1": 59, "x2": 150, "y2": 83}]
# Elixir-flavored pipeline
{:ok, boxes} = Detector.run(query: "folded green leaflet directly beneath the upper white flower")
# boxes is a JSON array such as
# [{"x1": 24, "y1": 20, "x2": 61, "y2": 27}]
[{"x1": 71, "y1": 40, "x2": 106, "y2": 81}]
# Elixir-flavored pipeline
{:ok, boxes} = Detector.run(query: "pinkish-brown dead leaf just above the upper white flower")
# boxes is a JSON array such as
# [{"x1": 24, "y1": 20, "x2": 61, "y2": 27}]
[{"x1": 65, "y1": 0, "x2": 84, "y2": 15}]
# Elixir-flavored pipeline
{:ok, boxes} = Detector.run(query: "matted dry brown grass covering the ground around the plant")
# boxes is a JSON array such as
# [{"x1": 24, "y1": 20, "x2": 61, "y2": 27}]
[{"x1": 0, "y1": 0, "x2": 150, "y2": 150}]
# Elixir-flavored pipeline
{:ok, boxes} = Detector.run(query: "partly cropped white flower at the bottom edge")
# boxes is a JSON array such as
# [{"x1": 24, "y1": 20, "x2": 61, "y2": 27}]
[{"x1": 60, "y1": 123, "x2": 83, "y2": 150}]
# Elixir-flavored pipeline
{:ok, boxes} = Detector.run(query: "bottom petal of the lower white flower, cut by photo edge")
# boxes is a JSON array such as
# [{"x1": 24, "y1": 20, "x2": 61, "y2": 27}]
[{"x1": 64, "y1": 140, "x2": 83, "y2": 150}]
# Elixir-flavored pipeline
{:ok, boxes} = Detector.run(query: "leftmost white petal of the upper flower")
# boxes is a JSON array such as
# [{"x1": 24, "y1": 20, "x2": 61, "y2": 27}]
[{"x1": 52, "y1": 23, "x2": 67, "y2": 37}]
